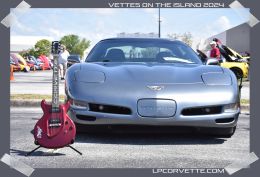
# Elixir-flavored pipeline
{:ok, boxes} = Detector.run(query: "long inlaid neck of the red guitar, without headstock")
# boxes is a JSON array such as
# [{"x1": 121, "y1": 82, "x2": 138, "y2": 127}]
[{"x1": 52, "y1": 54, "x2": 59, "y2": 112}]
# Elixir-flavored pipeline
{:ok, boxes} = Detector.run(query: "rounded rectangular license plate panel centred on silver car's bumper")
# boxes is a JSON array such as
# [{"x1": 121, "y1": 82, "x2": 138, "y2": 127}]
[{"x1": 137, "y1": 99, "x2": 176, "y2": 118}]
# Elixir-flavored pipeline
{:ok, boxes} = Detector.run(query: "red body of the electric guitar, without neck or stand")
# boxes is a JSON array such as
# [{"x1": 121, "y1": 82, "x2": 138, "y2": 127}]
[{"x1": 34, "y1": 100, "x2": 76, "y2": 149}]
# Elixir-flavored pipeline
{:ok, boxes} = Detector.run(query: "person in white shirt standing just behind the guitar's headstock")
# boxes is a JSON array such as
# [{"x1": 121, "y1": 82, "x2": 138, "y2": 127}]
[{"x1": 59, "y1": 45, "x2": 70, "y2": 80}]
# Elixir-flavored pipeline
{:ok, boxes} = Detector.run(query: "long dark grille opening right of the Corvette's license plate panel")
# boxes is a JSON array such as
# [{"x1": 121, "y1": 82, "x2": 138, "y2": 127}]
[{"x1": 182, "y1": 106, "x2": 222, "y2": 116}]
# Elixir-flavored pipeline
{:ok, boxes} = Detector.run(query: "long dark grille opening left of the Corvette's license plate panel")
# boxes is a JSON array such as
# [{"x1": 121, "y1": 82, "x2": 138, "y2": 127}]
[{"x1": 89, "y1": 103, "x2": 132, "y2": 115}]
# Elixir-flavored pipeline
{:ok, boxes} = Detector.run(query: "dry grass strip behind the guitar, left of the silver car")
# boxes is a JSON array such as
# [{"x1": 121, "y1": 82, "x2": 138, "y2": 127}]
[{"x1": 10, "y1": 94, "x2": 65, "y2": 101}]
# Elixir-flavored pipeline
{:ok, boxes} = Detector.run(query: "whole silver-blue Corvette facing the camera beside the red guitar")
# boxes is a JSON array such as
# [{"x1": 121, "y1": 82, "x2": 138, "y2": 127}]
[{"x1": 65, "y1": 38, "x2": 240, "y2": 137}]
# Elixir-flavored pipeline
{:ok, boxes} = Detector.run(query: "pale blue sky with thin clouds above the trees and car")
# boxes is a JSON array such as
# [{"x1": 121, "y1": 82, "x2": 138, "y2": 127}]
[{"x1": 11, "y1": 8, "x2": 249, "y2": 48}]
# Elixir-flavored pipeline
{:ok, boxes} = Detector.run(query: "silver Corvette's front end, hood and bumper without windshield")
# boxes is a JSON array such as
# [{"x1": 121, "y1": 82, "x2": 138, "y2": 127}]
[{"x1": 66, "y1": 37, "x2": 240, "y2": 137}]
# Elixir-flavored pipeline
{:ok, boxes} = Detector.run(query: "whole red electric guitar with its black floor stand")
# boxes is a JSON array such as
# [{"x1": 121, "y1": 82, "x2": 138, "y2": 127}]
[{"x1": 27, "y1": 41, "x2": 81, "y2": 155}]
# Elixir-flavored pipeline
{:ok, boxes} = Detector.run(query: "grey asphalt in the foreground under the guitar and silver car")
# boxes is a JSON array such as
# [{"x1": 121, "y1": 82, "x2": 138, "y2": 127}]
[{"x1": 10, "y1": 107, "x2": 250, "y2": 168}]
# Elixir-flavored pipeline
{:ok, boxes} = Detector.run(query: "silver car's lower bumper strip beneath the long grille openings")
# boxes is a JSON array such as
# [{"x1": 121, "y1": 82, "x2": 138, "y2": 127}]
[{"x1": 68, "y1": 106, "x2": 240, "y2": 128}]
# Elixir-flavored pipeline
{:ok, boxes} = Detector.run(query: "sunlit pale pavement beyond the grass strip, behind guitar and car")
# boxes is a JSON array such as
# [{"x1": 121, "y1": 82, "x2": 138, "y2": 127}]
[{"x1": 10, "y1": 70, "x2": 250, "y2": 99}]
